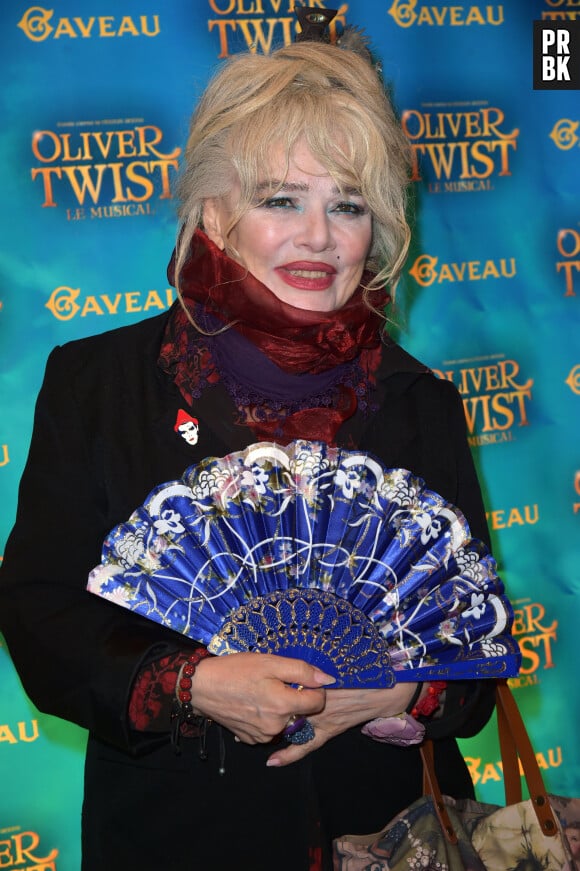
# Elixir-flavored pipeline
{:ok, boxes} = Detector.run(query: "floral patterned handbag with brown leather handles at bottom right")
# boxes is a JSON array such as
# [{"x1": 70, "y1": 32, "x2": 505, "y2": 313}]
[{"x1": 334, "y1": 682, "x2": 580, "y2": 871}]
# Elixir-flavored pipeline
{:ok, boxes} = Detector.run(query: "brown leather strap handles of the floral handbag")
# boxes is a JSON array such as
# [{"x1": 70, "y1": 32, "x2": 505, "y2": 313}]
[{"x1": 421, "y1": 681, "x2": 558, "y2": 844}]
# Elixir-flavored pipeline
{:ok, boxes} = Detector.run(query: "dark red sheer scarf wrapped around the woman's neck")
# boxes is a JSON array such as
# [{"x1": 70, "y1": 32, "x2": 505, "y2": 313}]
[{"x1": 160, "y1": 230, "x2": 389, "y2": 443}]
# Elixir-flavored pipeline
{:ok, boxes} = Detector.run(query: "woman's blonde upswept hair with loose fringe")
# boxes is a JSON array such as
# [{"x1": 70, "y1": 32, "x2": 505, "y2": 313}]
[{"x1": 176, "y1": 42, "x2": 410, "y2": 304}]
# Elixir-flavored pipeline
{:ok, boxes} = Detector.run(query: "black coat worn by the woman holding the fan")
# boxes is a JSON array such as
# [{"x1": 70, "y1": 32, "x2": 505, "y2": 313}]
[{"x1": 0, "y1": 313, "x2": 491, "y2": 871}]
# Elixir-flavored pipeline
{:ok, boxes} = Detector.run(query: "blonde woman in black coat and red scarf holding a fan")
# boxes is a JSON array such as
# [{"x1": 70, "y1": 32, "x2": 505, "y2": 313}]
[{"x1": 0, "y1": 34, "x2": 498, "y2": 871}]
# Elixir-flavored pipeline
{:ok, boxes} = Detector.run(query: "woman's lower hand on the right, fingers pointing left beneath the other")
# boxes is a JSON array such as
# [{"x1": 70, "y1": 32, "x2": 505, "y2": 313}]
[{"x1": 267, "y1": 683, "x2": 417, "y2": 766}]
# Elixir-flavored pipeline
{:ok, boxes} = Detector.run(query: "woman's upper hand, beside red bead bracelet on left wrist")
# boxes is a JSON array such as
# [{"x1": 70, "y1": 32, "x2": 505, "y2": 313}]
[{"x1": 191, "y1": 653, "x2": 334, "y2": 744}]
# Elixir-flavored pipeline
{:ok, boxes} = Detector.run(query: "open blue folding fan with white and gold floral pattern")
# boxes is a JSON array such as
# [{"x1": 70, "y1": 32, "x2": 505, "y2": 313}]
[{"x1": 88, "y1": 440, "x2": 520, "y2": 688}]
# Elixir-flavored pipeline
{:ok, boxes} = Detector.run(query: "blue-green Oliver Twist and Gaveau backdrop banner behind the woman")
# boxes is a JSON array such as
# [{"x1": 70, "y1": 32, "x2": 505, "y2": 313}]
[{"x1": 0, "y1": 0, "x2": 580, "y2": 871}]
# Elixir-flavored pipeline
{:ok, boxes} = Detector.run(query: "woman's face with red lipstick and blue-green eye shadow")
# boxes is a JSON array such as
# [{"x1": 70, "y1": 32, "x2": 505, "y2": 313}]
[{"x1": 203, "y1": 143, "x2": 372, "y2": 312}]
